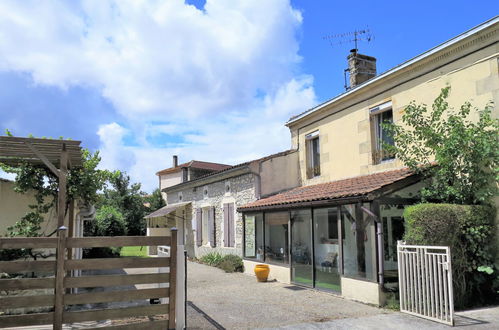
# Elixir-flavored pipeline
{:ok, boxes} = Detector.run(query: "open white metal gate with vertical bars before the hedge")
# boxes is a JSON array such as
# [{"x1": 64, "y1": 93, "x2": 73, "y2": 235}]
[{"x1": 397, "y1": 241, "x2": 454, "y2": 325}]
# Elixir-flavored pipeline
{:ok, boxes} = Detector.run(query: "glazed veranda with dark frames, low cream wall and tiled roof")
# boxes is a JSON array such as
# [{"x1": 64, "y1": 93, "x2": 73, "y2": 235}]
[{"x1": 238, "y1": 169, "x2": 421, "y2": 305}]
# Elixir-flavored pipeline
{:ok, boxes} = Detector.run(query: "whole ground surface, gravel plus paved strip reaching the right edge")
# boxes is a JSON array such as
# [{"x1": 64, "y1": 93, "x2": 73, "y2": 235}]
[{"x1": 187, "y1": 262, "x2": 499, "y2": 330}]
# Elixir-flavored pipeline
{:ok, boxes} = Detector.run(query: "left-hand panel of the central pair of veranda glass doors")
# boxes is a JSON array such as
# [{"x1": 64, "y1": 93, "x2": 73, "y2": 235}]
[{"x1": 291, "y1": 210, "x2": 314, "y2": 286}]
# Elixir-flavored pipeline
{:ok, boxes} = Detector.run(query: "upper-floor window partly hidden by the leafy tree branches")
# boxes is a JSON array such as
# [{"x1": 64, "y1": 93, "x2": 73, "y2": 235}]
[{"x1": 369, "y1": 101, "x2": 395, "y2": 164}]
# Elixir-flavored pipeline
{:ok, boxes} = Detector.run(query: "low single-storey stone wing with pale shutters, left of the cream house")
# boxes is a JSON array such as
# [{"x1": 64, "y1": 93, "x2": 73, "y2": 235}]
[{"x1": 162, "y1": 150, "x2": 300, "y2": 257}]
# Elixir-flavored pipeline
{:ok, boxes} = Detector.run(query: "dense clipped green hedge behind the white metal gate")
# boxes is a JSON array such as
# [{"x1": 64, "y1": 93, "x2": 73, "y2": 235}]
[{"x1": 404, "y1": 204, "x2": 498, "y2": 308}]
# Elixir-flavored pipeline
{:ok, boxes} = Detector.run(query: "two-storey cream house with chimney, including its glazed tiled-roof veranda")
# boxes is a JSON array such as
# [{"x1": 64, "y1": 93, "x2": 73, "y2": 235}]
[{"x1": 237, "y1": 17, "x2": 499, "y2": 305}]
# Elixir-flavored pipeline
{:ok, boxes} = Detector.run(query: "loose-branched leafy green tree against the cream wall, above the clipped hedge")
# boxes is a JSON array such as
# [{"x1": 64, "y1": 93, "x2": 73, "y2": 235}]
[{"x1": 384, "y1": 87, "x2": 499, "y2": 204}]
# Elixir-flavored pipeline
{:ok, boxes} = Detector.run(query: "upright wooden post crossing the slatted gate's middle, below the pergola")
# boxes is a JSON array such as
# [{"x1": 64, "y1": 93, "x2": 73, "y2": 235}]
[{"x1": 53, "y1": 226, "x2": 67, "y2": 330}]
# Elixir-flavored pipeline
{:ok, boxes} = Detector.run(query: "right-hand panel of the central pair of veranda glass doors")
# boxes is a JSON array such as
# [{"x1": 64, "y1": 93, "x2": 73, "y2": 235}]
[{"x1": 314, "y1": 207, "x2": 341, "y2": 292}]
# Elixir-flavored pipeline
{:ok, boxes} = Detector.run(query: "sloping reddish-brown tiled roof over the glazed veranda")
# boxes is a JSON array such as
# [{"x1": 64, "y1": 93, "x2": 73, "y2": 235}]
[{"x1": 238, "y1": 168, "x2": 414, "y2": 210}]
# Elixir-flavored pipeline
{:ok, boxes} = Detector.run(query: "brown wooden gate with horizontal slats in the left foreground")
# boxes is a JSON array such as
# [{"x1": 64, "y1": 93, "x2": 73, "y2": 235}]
[{"x1": 0, "y1": 227, "x2": 182, "y2": 329}]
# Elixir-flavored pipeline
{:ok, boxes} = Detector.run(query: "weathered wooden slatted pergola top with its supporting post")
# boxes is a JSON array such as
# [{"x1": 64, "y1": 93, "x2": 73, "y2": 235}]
[{"x1": 0, "y1": 136, "x2": 83, "y2": 228}]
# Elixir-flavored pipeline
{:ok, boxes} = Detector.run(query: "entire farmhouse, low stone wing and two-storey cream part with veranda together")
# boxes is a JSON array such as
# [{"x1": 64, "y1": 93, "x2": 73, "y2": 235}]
[{"x1": 149, "y1": 17, "x2": 499, "y2": 305}]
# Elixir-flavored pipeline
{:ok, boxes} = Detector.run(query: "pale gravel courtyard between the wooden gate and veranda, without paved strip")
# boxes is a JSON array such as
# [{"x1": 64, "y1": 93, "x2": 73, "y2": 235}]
[{"x1": 187, "y1": 262, "x2": 390, "y2": 329}]
